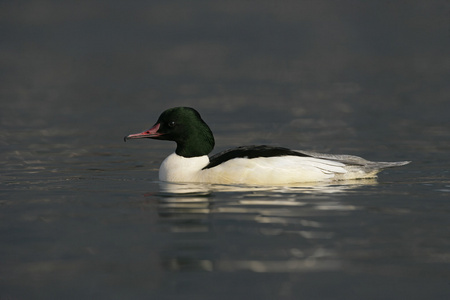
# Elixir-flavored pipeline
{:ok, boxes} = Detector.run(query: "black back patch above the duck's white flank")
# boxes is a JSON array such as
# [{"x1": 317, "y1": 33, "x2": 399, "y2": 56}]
[{"x1": 203, "y1": 145, "x2": 311, "y2": 169}]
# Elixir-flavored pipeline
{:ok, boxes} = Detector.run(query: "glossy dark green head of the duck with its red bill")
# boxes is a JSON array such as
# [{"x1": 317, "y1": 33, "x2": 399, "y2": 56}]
[{"x1": 124, "y1": 107, "x2": 214, "y2": 157}]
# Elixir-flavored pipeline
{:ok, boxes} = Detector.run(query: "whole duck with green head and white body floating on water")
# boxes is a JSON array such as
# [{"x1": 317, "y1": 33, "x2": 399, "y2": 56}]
[{"x1": 124, "y1": 107, "x2": 409, "y2": 185}]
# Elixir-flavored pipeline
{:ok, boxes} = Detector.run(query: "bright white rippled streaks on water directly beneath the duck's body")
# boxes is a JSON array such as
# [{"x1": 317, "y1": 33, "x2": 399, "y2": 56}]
[{"x1": 158, "y1": 180, "x2": 377, "y2": 219}]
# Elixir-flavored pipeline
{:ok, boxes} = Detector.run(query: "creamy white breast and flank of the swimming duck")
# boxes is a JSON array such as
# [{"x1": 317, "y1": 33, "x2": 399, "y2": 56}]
[{"x1": 159, "y1": 153, "x2": 384, "y2": 185}]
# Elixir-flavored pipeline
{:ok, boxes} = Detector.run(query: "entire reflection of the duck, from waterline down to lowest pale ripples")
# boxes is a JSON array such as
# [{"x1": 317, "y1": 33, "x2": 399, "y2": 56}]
[{"x1": 154, "y1": 180, "x2": 376, "y2": 273}]
